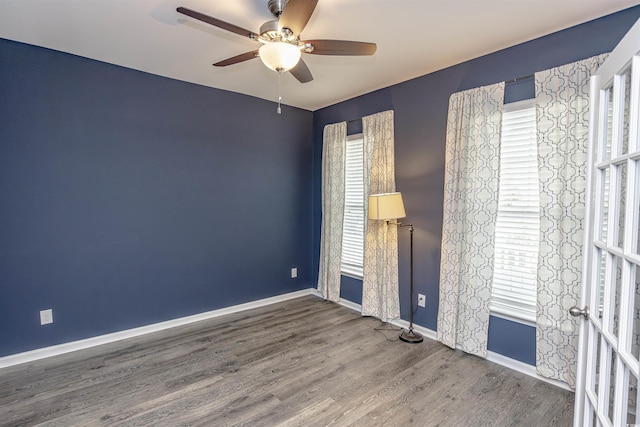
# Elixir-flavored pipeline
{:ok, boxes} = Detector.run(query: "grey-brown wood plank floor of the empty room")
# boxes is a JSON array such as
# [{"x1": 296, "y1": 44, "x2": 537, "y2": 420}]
[{"x1": 0, "y1": 296, "x2": 573, "y2": 427}]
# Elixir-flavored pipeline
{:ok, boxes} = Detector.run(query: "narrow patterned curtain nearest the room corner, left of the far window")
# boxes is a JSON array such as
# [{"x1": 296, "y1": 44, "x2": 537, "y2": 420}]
[{"x1": 318, "y1": 122, "x2": 347, "y2": 302}]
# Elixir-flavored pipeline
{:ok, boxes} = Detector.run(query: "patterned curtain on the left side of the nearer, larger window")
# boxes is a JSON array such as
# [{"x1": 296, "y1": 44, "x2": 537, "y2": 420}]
[{"x1": 438, "y1": 83, "x2": 504, "y2": 357}]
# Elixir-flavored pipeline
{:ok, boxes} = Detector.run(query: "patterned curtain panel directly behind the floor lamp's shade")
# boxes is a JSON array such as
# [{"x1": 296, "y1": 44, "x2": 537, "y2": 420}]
[{"x1": 362, "y1": 111, "x2": 400, "y2": 321}]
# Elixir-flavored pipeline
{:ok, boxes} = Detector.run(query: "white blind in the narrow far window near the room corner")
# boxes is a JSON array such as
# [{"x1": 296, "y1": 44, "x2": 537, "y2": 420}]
[{"x1": 342, "y1": 134, "x2": 364, "y2": 279}]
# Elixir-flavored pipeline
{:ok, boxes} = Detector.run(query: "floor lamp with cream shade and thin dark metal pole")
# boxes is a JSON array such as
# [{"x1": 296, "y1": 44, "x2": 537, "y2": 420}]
[{"x1": 368, "y1": 193, "x2": 423, "y2": 343}]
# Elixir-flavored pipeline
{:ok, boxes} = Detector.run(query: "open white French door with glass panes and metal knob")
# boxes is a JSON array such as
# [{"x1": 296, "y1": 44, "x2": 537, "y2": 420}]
[{"x1": 570, "y1": 17, "x2": 640, "y2": 427}]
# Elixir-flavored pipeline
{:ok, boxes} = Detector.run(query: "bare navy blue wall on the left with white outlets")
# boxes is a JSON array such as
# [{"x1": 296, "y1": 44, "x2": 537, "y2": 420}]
[{"x1": 0, "y1": 40, "x2": 313, "y2": 356}]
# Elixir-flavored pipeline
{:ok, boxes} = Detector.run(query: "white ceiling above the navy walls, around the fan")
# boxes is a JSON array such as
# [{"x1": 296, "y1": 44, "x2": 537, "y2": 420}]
[{"x1": 0, "y1": 0, "x2": 638, "y2": 111}]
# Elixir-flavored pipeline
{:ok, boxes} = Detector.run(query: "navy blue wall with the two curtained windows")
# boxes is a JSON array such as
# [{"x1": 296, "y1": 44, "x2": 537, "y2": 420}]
[{"x1": 313, "y1": 7, "x2": 640, "y2": 364}]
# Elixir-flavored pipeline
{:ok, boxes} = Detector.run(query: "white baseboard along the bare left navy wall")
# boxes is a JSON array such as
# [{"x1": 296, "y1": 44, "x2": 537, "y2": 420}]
[{"x1": 0, "y1": 289, "x2": 314, "y2": 369}]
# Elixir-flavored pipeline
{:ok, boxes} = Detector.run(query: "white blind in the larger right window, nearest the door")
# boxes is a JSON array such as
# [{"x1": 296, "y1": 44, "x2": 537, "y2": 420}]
[{"x1": 491, "y1": 99, "x2": 540, "y2": 322}]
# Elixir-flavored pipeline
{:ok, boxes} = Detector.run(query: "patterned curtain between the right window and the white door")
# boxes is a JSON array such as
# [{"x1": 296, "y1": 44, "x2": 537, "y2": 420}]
[{"x1": 535, "y1": 55, "x2": 607, "y2": 386}]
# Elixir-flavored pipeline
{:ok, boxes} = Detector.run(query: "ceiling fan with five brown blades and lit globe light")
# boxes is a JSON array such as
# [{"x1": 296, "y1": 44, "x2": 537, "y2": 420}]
[{"x1": 176, "y1": 0, "x2": 377, "y2": 83}]
